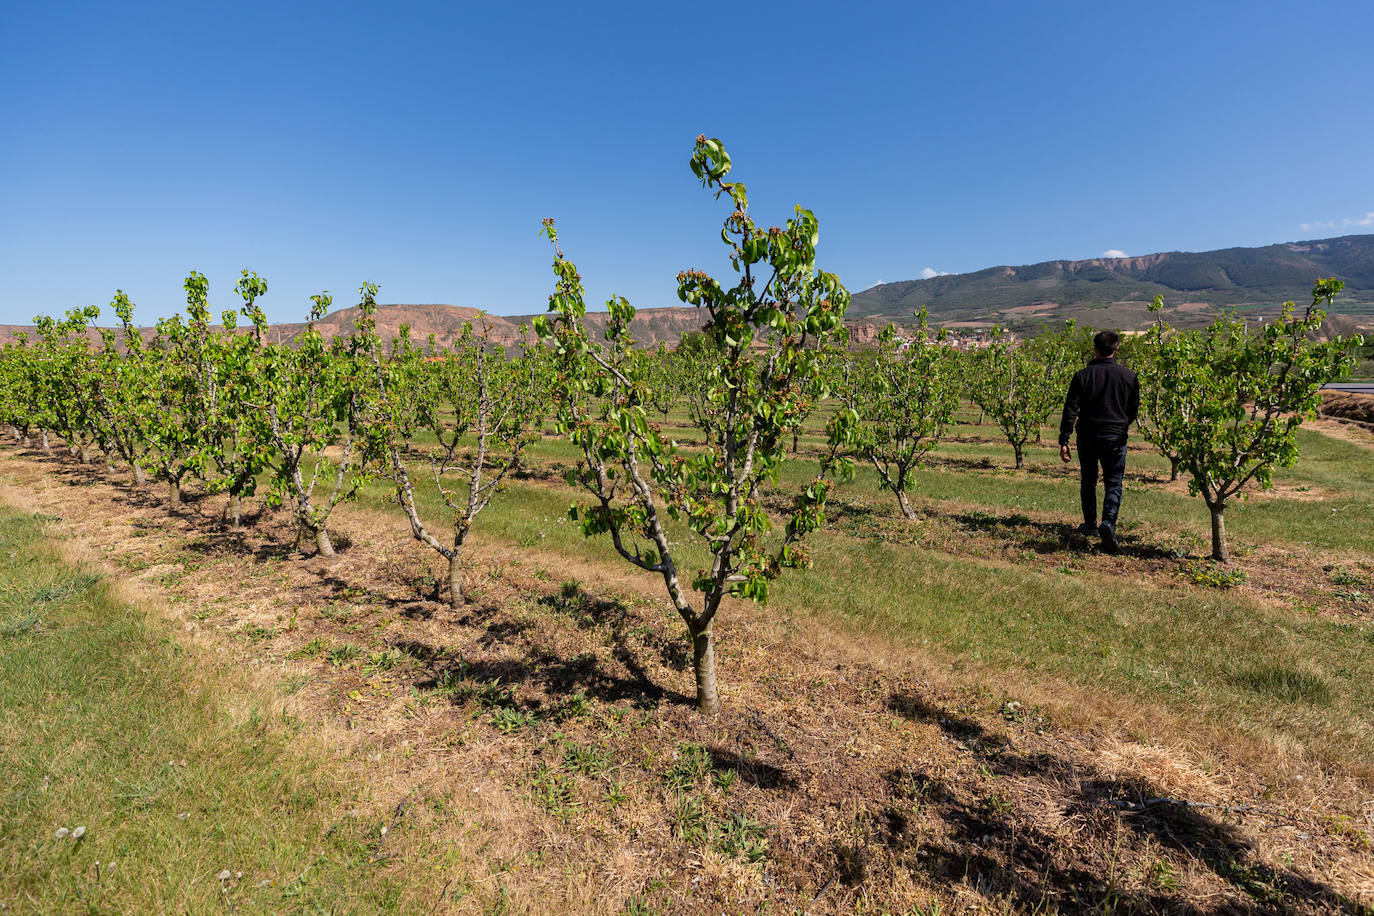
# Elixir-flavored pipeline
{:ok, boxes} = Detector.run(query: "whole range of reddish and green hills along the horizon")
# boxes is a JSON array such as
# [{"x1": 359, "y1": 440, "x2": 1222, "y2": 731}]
[{"x1": 0, "y1": 235, "x2": 1374, "y2": 346}]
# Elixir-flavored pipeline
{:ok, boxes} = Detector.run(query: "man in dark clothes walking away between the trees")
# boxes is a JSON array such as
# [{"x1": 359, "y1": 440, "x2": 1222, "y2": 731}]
[{"x1": 1059, "y1": 331, "x2": 1140, "y2": 553}]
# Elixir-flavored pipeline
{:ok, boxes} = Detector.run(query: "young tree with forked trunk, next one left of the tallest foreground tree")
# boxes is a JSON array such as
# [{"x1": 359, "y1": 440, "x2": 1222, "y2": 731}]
[{"x1": 360, "y1": 307, "x2": 547, "y2": 608}]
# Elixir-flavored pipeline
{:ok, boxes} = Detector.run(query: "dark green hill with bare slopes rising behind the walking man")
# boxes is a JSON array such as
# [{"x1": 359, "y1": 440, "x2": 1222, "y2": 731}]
[{"x1": 849, "y1": 235, "x2": 1374, "y2": 331}]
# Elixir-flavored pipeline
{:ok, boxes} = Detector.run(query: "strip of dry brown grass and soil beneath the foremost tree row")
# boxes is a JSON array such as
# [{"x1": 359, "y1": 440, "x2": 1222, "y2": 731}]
[{"x1": 0, "y1": 446, "x2": 1374, "y2": 913}]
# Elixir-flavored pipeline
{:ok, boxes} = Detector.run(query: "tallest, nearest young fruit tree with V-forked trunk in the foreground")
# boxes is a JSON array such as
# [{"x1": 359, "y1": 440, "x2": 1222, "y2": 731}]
[{"x1": 536, "y1": 136, "x2": 849, "y2": 714}]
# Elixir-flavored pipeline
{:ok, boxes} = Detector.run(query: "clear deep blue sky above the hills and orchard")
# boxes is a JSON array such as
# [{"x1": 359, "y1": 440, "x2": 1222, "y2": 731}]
[{"x1": 0, "y1": 0, "x2": 1374, "y2": 323}]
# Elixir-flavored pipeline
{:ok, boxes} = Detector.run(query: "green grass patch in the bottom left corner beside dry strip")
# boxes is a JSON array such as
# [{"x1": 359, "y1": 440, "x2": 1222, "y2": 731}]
[{"x1": 0, "y1": 508, "x2": 425, "y2": 913}]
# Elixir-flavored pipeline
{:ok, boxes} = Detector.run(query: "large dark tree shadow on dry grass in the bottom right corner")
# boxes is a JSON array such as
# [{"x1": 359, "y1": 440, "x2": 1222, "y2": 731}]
[{"x1": 879, "y1": 694, "x2": 1369, "y2": 915}]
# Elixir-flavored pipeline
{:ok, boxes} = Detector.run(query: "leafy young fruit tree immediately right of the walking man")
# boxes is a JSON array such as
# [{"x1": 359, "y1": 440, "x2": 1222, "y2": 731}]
[{"x1": 1147, "y1": 279, "x2": 1363, "y2": 563}]
